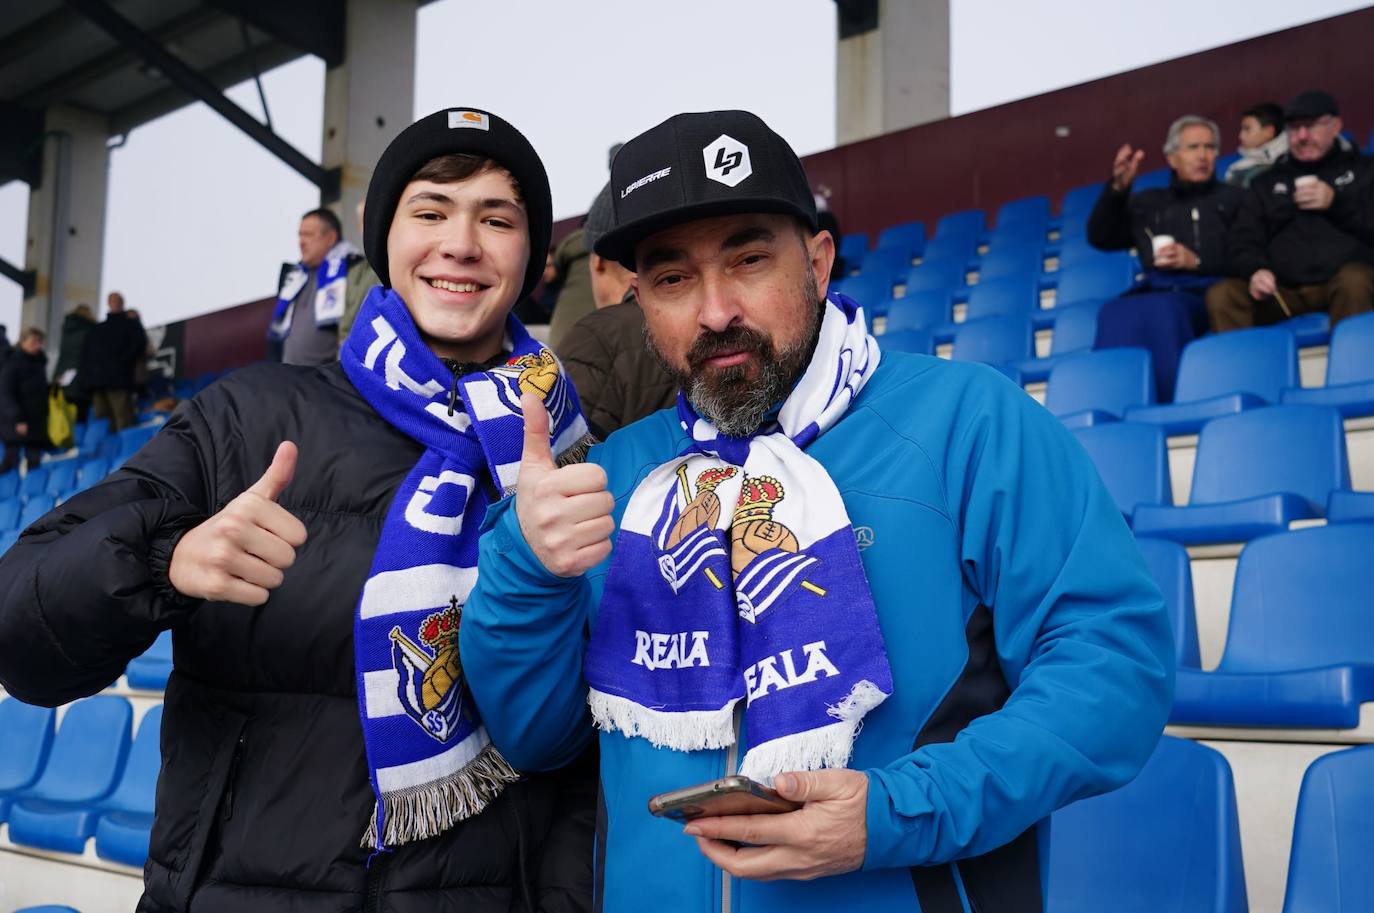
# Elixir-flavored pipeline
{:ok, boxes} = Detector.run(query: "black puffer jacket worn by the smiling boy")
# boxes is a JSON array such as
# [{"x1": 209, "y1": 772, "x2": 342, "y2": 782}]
[{"x1": 0, "y1": 363, "x2": 596, "y2": 913}]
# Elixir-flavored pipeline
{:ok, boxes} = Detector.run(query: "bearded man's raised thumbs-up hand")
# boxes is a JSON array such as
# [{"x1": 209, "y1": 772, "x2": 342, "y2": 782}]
[{"x1": 515, "y1": 393, "x2": 616, "y2": 578}]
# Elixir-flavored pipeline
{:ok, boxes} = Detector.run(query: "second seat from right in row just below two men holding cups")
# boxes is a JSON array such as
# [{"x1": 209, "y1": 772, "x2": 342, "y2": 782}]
[{"x1": 1125, "y1": 327, "x2": 1297, "y2": 435}]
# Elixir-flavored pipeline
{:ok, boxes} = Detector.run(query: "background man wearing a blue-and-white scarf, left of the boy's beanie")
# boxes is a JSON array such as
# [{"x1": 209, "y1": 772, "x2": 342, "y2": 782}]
[{"x1": 268, "y1": 209, "x2": 363, "y2": 366}]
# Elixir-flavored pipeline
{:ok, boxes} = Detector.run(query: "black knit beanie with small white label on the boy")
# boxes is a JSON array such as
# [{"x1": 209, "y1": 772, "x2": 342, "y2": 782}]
[{"x1": 363, "y1": 107, "x2": 554, "y2": 298}]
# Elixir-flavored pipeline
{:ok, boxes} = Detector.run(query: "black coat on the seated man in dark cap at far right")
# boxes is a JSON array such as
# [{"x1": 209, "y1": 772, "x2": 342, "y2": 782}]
[{"x1": 1230, "y1": 143, "x2": 1374, "y2": 286}]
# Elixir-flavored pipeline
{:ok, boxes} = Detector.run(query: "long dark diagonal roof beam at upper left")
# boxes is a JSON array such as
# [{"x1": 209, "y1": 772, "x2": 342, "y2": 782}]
[{"x1": 66, "y1": 0, "x2": 339, "y2": 202}]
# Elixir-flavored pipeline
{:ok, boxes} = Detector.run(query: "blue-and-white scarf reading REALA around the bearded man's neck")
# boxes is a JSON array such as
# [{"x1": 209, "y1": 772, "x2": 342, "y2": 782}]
[{"x1": 584, "y1": 294, "x2": 892, "y2": 782}]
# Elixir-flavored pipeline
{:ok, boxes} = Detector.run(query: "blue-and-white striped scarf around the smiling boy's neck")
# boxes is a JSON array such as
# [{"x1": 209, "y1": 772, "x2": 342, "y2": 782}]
[{"x1": 341, "y1": 286, "x2": 588, "y2": 848}]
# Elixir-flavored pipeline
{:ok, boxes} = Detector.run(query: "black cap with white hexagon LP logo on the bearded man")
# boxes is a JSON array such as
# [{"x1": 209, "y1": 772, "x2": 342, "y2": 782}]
[{"x1": 595, "y1": 111, "x2": 818, "y2": 270}]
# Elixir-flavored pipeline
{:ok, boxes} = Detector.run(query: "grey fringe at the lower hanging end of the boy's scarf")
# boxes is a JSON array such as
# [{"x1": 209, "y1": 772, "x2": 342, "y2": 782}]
[{"x1": 361, "y1": 745, "x2": 519, "y2": 850}]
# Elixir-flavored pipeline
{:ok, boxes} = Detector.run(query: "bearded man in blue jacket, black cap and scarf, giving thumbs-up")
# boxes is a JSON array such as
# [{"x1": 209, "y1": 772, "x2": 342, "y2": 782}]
[{"x1": 460, "y1": 111, "x2": 1173, "y2": 913}]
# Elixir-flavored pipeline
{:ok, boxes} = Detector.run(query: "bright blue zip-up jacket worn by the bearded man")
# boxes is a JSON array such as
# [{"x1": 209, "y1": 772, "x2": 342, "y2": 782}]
[{"x1": 460, "y1": 352, "x2": 1173, "y2": 913}]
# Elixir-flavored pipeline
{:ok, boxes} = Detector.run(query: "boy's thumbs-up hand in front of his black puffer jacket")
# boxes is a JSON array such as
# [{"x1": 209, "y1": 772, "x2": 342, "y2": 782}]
[{"x1": 168, "y1": 441, "x2": 305, "y2": 605}]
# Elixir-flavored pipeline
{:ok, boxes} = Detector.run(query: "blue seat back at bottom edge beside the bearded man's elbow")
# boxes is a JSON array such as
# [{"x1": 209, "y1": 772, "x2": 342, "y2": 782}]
[{"x1": 1046, "y1": 736, "x2": 1248, "y2": 913}]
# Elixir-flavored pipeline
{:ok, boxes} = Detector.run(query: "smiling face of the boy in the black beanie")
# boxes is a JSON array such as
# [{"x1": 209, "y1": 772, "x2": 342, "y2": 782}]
[{"x1": 386, "y1": 155, "x2": 529, "y2": 362}]
